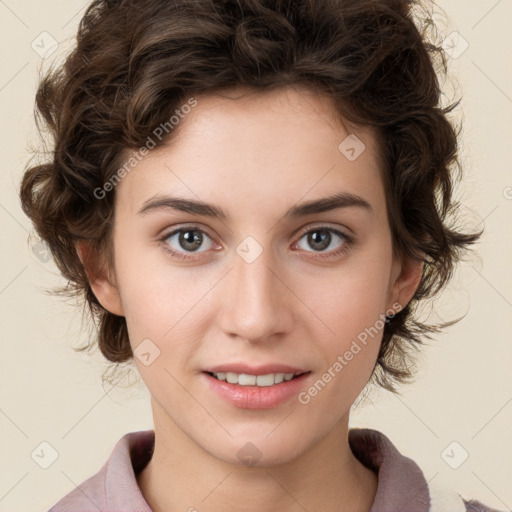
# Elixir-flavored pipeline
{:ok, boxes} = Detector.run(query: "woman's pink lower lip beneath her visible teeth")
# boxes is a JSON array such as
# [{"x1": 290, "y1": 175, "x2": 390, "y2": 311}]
[{"x1": 203, "y1": 372, "x2": 310, "y2": 409}]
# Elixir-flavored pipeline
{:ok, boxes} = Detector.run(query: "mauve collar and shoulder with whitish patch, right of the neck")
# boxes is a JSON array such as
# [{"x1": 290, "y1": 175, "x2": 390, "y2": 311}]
[{"x1": 349, "y1": 428, "x2": 502, "y2": 512}]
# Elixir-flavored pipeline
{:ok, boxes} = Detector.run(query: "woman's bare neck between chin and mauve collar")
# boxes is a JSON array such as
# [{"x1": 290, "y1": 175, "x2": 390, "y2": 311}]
[{"x1": 137, "y1": 400, "x2": 377, "y2": 512}]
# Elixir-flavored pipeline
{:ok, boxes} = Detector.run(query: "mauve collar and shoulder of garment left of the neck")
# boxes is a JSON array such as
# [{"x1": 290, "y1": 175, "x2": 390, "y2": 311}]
[{"x1": 48, "y1": 430, "x2": 154, "y2": 512}]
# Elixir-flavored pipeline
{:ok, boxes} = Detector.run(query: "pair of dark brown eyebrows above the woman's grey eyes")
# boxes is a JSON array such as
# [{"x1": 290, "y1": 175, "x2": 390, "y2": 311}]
[{"x1": 138, "y1": 192, "x2": 373, "y2": 220}]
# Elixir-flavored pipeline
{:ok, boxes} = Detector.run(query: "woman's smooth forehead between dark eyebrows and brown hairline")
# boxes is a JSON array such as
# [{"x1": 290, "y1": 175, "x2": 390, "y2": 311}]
[{"x1": 116, "y1": 87, "x2": 382, "y2": 217}]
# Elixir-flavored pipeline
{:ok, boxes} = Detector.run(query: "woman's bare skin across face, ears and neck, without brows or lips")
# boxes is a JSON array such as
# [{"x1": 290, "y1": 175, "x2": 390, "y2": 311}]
[{"x1": 79, "y1": 87, "x2": 421, "y2": 512}]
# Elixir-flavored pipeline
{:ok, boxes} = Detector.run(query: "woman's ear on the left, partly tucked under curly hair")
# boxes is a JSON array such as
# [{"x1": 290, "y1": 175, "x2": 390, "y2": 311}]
[{"x1": 76, "y1": 241, "x2": 124, "y2": 316}]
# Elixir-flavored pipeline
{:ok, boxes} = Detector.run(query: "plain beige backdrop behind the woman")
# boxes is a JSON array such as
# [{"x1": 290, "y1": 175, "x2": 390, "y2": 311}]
[{"x1": 0, "y1": 0, "x2": 512, "y2": 512}]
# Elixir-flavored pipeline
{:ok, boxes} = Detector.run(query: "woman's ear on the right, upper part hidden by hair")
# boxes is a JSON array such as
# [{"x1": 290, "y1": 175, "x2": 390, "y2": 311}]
[{"x1": 388, "y1": 253, "x2": 423, "y2": 309}]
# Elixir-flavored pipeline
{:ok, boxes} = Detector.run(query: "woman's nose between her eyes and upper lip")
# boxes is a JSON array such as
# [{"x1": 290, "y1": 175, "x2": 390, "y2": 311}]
[{"x1": 220, "y1": 240, "x2": 293, "y2": 343}]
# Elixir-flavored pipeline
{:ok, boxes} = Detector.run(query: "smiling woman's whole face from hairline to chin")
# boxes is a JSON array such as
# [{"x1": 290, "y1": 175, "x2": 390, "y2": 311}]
[{"x1": 87, "y1": 88, "x2": 412, "y2": 465}]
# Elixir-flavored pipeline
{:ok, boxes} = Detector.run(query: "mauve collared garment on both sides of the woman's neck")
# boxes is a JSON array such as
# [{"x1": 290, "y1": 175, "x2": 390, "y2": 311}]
[{"x1": 48, "y1": 428, "x2": 500, "y2": 512}]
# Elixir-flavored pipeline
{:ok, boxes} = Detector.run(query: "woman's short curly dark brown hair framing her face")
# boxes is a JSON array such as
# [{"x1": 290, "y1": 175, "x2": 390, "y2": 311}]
[{"x1": 20, "y1": 0, "x2": 481, "y2": 391}]
